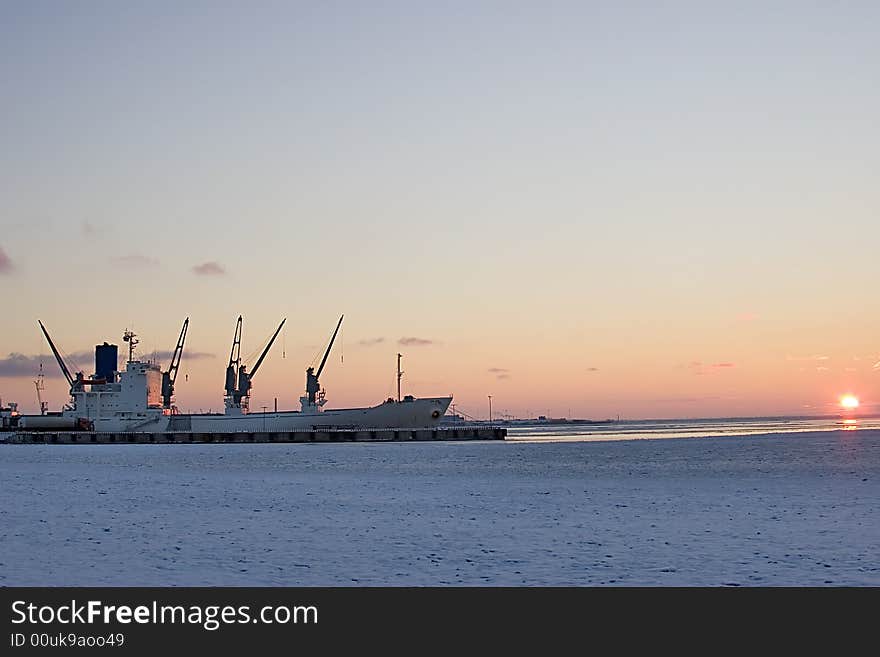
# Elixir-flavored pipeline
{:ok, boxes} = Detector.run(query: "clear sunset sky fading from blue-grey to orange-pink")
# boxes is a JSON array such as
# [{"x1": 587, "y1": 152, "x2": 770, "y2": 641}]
[{"x1": 0, "y1": 0, "x2": 880, "y2": 419}]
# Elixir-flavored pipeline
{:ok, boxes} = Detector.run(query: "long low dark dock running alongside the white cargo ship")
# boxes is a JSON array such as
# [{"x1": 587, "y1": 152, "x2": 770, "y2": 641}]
[{"x1": 0, "y1": 426, "x2": 507, "y2": 445}]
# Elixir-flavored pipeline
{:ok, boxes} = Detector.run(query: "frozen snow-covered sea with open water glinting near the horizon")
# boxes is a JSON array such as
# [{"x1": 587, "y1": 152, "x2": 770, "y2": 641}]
[{"x1": 0, "y1": 420, "x2": 880, "y2": 586}]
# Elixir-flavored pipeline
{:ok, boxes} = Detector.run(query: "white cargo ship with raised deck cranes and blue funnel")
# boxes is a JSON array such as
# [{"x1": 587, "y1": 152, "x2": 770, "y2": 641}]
[{"x1": 2, "y1": 317, "x2": 452, "y2": 433}]
